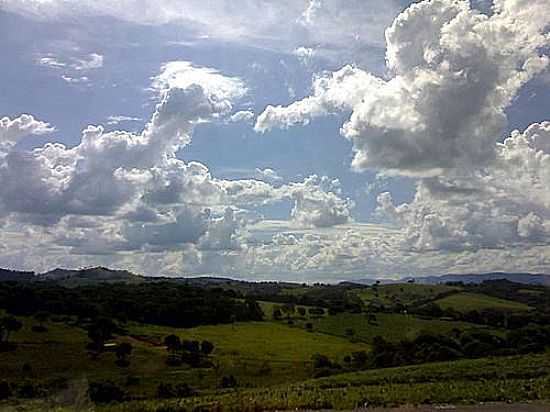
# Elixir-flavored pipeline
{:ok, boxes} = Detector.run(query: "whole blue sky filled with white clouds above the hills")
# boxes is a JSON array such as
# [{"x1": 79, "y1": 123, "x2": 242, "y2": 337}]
[{"x1": 0, "y1": 0, "x2": 550, "y2": 282}]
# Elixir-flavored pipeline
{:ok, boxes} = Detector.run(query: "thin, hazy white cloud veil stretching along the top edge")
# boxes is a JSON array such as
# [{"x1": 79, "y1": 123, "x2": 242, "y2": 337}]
[{"x1": 3, "y1": 0, "x2": 402, "y2": 61}]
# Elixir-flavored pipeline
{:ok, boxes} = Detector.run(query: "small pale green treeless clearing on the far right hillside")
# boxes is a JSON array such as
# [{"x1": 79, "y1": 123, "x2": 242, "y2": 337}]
[{"x1": 435, "y1": 293, "x2": 531, "y2": 312}]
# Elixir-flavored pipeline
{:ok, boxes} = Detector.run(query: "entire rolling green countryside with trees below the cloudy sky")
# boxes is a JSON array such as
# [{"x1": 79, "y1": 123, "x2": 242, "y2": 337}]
[{"x1": 0, "y1": 268, "x2": 550, "y2": 411}]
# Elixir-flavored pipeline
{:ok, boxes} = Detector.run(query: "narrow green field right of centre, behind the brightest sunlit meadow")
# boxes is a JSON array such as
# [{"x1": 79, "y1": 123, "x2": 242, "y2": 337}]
[{"x1": 297, "y1": 313, "x2": 491, "y2": 342}]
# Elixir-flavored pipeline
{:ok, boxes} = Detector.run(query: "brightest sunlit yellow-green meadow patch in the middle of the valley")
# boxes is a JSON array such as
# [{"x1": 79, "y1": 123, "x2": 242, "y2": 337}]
[{"x1": 129, "y1": 322, "x2": 368, "y2": 386}]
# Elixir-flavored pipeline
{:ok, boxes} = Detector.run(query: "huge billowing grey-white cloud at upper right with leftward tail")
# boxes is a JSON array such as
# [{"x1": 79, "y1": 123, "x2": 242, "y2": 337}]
[{"x1": 255, "y1": 0, "x2": 550, "y2": 176}]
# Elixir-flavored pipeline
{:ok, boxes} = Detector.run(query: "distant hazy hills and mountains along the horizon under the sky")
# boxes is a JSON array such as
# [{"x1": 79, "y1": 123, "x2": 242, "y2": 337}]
[{"x1": 0, "y1": 267, "x2": 550, "y2": 288}]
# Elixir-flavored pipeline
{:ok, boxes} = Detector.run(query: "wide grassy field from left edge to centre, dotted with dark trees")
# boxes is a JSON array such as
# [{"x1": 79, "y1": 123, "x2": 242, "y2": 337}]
[{"x1": 0, "y1": 318, "x2": 368, "y2": 396}]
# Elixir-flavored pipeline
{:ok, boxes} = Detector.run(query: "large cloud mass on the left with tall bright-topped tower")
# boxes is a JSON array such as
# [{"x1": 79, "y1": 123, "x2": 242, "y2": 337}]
[{"x1": 0, "y1": 62, "x2": 351, "y2": 272}]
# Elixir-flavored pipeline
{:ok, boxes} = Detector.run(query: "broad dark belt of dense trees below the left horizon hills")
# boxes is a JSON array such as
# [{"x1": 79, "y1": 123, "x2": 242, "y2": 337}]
[{"x1": 0, "y1": 282, "x2": 264, "y2": 327}]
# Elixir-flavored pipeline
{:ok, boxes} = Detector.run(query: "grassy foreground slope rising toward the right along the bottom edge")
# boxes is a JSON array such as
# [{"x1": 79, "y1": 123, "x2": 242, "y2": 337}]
[{"x1": 99, "y1": 354, "x2": 550, "y2": 412}]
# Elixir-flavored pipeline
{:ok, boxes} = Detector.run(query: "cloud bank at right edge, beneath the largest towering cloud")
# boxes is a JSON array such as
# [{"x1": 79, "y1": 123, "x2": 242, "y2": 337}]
[{"x1": 378, "y1": 122, "x2": 550, "y2": 251}]
